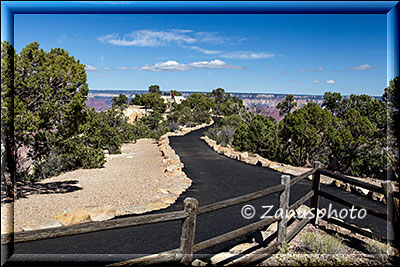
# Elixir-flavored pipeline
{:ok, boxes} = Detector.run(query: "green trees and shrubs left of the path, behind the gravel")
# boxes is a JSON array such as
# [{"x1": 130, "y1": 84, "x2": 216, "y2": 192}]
[{"x1": 1, "y1": 42, "x2": 168, "y2": 197}]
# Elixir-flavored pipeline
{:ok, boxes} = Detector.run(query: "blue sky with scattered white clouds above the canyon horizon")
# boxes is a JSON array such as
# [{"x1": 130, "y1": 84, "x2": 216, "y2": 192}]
[{"x1": 14, "y1": 14, "x2": 386, "y2": 96}]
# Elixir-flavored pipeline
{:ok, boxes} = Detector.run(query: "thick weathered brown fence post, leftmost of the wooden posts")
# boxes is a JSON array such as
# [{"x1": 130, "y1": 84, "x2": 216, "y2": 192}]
[{"x1": 180, "y1": 197, "x2": 199, "y2": 265}]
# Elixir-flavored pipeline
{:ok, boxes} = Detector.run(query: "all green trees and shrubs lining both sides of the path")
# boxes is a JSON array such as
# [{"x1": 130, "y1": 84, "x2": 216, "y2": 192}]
[{"x1": 1, "y1": 42, "x2": 400, "y2": 201}]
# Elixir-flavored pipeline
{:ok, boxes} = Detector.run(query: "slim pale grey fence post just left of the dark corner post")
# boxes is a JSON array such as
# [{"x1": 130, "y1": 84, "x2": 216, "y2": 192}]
[{"x1": 278, "y1": 175, "x2": 290, "y2": 248}]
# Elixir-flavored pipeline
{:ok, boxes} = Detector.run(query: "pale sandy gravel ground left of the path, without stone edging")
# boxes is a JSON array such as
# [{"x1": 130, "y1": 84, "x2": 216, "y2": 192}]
[{"x1": 1, "y1": 139, "x2": 173, "y2": 233}]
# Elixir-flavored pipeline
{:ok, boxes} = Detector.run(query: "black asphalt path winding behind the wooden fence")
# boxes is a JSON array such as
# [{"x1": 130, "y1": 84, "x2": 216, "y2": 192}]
[{"x1": 2, "y1": 120, "x2": 386, "y2": 266}]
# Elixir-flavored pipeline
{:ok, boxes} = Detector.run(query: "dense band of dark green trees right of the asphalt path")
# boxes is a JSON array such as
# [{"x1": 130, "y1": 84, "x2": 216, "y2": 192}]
[{"x1": 206, "y1": 77, "x2": 400, "y2": 178}]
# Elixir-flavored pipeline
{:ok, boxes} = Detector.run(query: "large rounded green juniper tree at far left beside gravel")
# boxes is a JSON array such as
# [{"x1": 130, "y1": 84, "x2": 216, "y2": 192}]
[{"x1": 2, "y1": 42, "x2": 95, "y2": 180}]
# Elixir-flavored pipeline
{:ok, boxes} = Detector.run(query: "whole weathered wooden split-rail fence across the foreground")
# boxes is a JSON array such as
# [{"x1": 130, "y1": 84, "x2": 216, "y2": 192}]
[{"x1": 1, "y1": 162, "x2": 399, "y2": 266}]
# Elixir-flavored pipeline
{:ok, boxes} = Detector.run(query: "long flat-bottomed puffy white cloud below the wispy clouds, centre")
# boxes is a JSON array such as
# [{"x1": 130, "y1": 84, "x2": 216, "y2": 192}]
[{"x1": 140, "y1": 59, "x2": 244, "y2": 72}]
